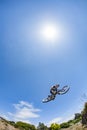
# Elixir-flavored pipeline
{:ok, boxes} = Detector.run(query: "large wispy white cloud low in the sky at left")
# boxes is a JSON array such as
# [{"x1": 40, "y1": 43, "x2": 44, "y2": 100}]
[{"x1": 8, "y1": 101, "x2": 40, "y2": 123}]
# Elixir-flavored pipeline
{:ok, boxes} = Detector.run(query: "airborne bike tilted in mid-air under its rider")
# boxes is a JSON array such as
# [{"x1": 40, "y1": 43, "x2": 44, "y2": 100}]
[{"x1": 42, "y1": 86, "x2": 70, "y2": 103}]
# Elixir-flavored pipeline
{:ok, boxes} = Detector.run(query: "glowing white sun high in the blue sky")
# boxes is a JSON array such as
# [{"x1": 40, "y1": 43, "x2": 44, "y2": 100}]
[{"x1": 41, "y1": 24, "x2": 58, "y2": 42}]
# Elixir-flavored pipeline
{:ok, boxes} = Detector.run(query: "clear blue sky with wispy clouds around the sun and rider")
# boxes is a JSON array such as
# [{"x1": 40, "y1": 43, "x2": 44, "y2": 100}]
[{"x1": 0, "y1": 0, "x2": 87, "y2": 125}]
